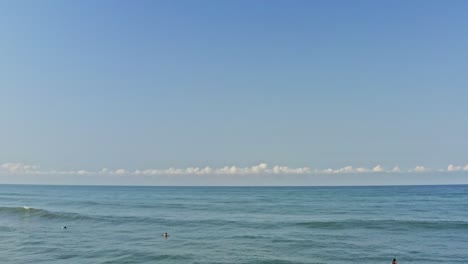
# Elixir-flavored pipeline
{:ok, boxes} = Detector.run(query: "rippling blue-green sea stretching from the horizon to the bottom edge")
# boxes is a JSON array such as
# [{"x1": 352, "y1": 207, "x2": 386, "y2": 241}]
[{"x1": 0, "y1": 185, "x2": 468, "y2": 264}]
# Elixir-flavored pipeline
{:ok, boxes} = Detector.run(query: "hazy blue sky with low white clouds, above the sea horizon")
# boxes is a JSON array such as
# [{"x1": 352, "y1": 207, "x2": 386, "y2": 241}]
[{"x1": 0, "y1": 0, "x2": 468, "y2": 185}]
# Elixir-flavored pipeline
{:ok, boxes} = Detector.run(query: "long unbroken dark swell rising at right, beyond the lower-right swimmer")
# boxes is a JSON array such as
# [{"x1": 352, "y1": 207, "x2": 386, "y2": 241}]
[{"x1": 296, "y1": 219, "x2": 468, "y2": 229}]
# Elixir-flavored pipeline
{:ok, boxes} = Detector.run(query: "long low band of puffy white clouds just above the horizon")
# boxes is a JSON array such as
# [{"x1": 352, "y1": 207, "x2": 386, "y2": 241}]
[{"x1": 0, "y1": 163, "x2": 468, "y2": 176}]
